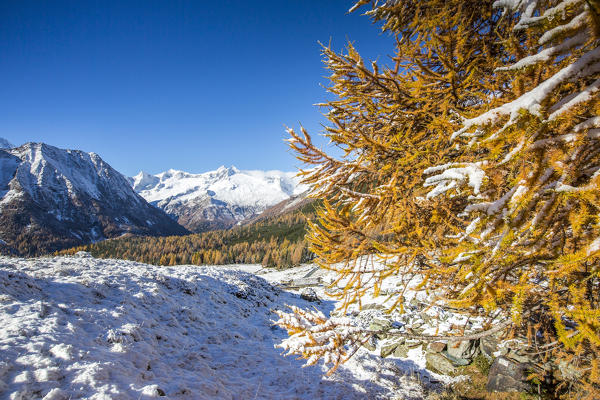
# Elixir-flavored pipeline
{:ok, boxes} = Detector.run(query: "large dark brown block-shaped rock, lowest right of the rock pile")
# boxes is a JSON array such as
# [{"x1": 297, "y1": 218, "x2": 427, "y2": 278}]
[{"x1": 486, "y1": 357, "x2": 530, "y2": 392}]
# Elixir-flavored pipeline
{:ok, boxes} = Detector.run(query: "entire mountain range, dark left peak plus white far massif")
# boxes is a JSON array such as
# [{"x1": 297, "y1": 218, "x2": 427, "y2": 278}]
[{"x1": 0, "y1": 138, "x2": 306, "y2": 255}]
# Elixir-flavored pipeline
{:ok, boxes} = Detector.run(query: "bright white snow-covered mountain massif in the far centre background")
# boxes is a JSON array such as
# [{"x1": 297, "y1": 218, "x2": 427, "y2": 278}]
[{"x1": 130, "y1": 167, "x2": 306, "y2": 232}]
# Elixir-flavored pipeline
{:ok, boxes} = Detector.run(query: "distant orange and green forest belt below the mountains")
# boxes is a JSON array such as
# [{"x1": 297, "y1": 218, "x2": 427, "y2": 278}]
[{"x1": 56, "y1": 203, "x2": 315, "y2": 268}]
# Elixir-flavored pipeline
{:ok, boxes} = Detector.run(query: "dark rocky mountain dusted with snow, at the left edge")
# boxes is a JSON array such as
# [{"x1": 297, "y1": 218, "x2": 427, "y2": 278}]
[{"x1": 0, "y1": 143, "x2": 186, "y2": 254}]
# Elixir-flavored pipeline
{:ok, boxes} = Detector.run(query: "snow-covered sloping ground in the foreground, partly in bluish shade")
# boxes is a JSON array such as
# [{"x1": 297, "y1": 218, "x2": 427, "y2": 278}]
[{"x1": 0, "y1": 255, "x2": 435, "y2": 399}]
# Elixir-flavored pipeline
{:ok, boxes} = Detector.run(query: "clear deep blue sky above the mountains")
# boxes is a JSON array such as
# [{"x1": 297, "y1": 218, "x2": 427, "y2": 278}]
[{"x1": 0, "y1": 0, "x2": 393, "y2": 175}]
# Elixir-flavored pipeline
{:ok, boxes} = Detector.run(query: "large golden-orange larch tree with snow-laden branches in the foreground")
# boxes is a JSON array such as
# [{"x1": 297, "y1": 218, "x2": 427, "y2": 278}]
[{"x1": 279, "y1": 0, "x2": 600, "y2": 399}]
